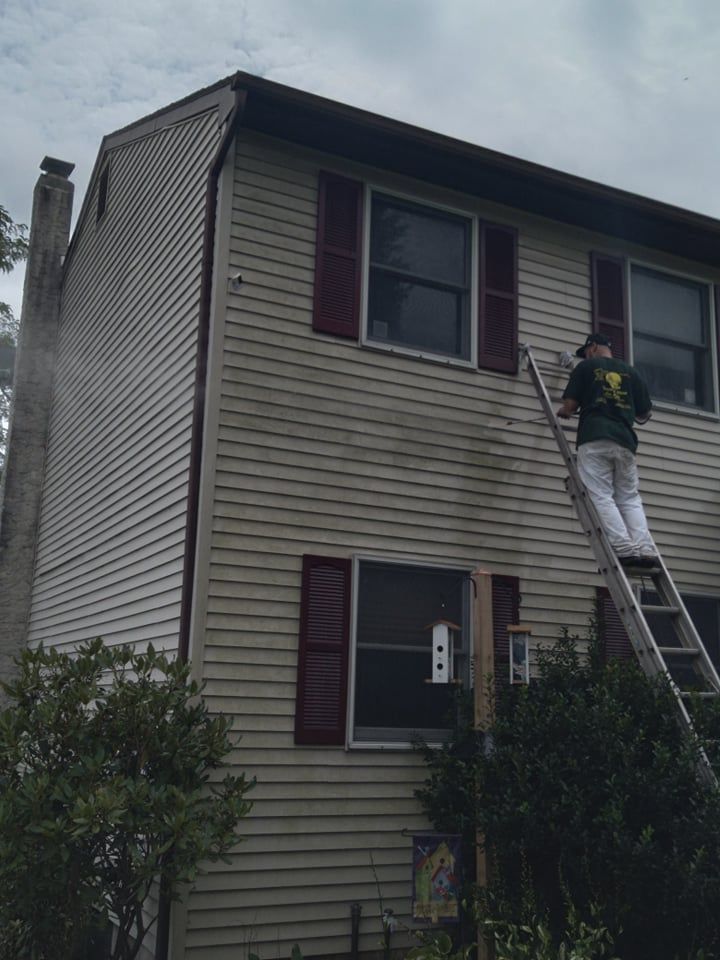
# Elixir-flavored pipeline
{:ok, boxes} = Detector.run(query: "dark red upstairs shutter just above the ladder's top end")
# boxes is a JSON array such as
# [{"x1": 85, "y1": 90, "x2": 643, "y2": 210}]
[{"x1": 478, "y1": 223, "x2": 518, "y2": 373}]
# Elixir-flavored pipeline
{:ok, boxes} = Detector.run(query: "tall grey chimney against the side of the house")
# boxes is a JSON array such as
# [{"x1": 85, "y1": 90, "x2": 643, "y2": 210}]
[{"x1": 0, "y1": 157, "x2": 74, "y2": 684}]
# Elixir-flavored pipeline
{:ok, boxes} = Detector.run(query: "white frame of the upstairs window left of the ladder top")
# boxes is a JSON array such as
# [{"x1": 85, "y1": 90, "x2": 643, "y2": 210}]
[{"x1": 360, "y1": 183, "x2": 480, "y2": 370}]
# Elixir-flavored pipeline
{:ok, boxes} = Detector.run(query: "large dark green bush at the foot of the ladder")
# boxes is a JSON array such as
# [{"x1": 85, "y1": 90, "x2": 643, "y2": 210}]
[{"x1": 418, "y1": 636, "x2": 720, "y2": 960}]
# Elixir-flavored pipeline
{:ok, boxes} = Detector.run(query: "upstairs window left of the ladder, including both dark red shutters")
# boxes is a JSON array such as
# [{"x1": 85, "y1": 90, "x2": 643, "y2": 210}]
[{"x1": 312, "y1": 171, "x2": 518, "y2": 374}]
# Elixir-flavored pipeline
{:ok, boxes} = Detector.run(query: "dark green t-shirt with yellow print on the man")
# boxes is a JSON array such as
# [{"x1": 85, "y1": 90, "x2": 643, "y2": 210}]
[{"x1": 563, "y1": 357, "x2": 652, "y2": 453}]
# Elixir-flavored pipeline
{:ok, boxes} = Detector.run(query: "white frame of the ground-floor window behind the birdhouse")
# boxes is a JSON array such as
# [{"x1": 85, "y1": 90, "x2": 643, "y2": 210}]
[{"x1": 345, "y1": 553, "x2": 477, "y2": 751}]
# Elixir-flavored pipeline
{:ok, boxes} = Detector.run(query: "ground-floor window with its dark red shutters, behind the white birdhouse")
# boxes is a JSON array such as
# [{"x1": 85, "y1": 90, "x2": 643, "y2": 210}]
[{"x1": 295, "y1": 554, "x2": 520, "y2": 747}]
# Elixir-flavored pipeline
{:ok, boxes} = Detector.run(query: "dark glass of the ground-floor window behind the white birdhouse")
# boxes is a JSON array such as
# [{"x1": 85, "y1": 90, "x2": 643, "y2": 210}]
[{"x1": 354, "y1": 561, "x2": 470, "y2": 742}]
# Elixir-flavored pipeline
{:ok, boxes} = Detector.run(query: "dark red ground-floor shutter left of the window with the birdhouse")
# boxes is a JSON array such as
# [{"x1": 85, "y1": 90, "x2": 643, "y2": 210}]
[{"x1": 295, "y1": 556, "x2": 351, "y2": 745}]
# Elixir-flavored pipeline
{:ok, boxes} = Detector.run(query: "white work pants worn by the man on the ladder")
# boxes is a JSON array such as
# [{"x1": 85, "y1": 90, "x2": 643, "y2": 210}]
[{"x1": 577, "y1": 440, "x2": 656, "y2": 557}]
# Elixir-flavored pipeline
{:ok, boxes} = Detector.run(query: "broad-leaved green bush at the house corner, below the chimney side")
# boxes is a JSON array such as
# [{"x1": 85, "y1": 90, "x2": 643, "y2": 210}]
[{"x1": 0, "y1": 640, "x2": 252, "y2": 960}]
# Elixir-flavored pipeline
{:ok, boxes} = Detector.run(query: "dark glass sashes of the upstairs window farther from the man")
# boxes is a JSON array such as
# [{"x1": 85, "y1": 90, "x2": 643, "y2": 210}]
[{"x1": 367, "y1": 193, "x2": 472, "y2": 361}]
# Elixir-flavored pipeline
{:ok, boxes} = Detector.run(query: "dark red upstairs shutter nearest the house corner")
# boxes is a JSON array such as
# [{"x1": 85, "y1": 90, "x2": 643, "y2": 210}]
[{"x1": 313, "y1": 172, "x2": 363, "y2": 339}]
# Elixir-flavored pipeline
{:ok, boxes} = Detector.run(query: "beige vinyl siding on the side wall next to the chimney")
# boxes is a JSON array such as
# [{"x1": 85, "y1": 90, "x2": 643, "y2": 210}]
[{"x1": 29, "y1": 110, "x2": 218, "y2": 650}]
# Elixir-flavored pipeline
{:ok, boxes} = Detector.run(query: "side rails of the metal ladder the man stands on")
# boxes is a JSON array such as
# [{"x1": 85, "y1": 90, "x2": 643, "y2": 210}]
[{"x1": 520, "y1": 344, "x2": 720, "y2": 786}]
